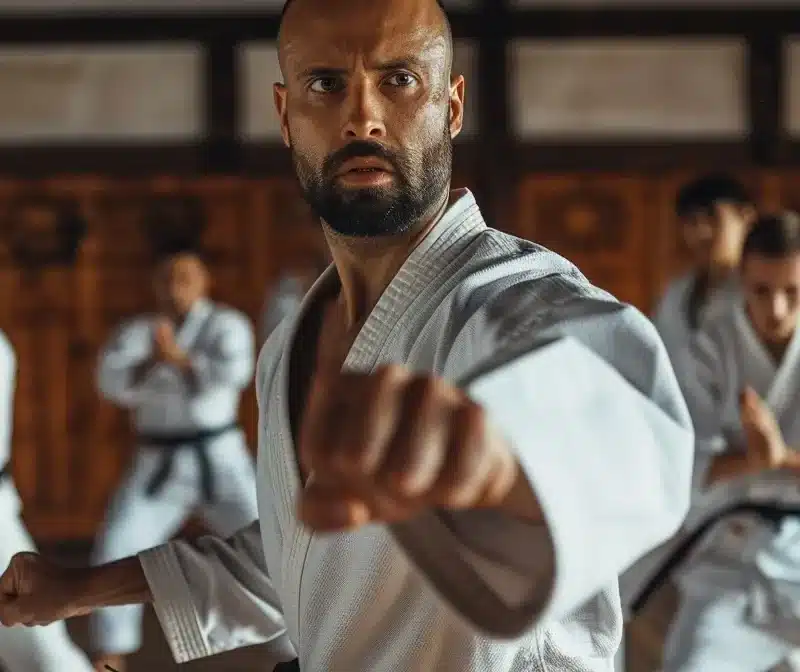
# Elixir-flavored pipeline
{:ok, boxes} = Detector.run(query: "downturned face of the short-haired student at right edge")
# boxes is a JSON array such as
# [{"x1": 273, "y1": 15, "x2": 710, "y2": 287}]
[{"x1": 742, "y1": 254, "x2": 800, "y2": 345}]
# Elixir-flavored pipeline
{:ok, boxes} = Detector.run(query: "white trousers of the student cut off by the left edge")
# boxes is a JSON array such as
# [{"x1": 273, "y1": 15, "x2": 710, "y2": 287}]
[{"x1": 0, "y1": 481, "x2": 92, "y2": 672}]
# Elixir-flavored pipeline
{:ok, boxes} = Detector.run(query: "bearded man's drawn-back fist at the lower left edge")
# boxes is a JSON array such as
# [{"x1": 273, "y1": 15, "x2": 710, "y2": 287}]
[{"x1": 0, "y1": 553, "x2": 88, "y2": 626}]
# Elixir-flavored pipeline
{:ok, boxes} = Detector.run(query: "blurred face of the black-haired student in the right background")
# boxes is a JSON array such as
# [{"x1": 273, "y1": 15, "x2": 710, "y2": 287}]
[{"x1": 683, "y1": 202, "x2": 752, "y2": 270}]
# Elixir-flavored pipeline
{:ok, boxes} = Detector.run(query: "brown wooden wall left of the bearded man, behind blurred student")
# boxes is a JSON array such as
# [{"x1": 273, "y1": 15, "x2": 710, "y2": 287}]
[{"x1": 0, "y1": 178, "x2": 332, "y2": 539}]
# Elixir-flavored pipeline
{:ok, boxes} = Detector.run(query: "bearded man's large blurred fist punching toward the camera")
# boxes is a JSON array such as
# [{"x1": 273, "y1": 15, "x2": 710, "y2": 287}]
[{"x1": 298, "y1": 366, "x2": 536, "y2": 531}]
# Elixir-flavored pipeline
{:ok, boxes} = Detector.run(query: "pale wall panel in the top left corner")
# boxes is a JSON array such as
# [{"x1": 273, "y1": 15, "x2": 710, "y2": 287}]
[{"x1": 0, "y1": 44, "x2": 203, "y2": 143}]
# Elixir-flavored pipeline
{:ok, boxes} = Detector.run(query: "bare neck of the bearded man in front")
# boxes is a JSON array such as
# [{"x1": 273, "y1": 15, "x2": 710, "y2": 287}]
[{"x1": 324, "y1": 196, "x2": 449, "y2": 328}]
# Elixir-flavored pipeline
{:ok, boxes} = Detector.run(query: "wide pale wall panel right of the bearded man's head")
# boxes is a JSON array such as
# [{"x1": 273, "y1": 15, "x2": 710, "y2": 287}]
[{"x1": 511, "y1": 39, "x2": 748, "y2": 139}]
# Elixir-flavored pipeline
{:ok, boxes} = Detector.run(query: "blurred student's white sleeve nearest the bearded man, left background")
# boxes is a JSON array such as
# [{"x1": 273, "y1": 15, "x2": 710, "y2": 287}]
[{"x1": 191, "y1": 311, "x2": 255, "y2": 394}]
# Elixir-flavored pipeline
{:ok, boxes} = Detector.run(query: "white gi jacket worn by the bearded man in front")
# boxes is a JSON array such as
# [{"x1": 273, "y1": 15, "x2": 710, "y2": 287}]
[{"x1": 140, "y1": 190, "x2": 694, "y2": 672}]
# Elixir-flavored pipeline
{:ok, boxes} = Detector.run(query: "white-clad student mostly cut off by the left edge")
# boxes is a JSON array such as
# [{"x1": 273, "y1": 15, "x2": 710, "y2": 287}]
[{"x1": 0, "y1": 331, "x2": 92, "y2": 672}]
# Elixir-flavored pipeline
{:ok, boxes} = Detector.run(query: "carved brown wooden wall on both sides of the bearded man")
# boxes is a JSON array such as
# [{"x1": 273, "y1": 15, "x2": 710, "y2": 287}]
[{"x1": 0, "y1": 170, "x2": 800, "y2": 540}]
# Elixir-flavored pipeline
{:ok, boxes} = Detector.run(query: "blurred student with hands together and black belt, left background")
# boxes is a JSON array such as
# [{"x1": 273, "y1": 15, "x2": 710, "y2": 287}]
[{"x1": 90, "y1": 245, "x2": 258, "y2": 672}]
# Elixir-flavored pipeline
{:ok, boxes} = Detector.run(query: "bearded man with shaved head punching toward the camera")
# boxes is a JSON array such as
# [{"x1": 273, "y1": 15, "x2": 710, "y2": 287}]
[{"x1": 0, "y1": 0, "x2": 694, "y2": 672}]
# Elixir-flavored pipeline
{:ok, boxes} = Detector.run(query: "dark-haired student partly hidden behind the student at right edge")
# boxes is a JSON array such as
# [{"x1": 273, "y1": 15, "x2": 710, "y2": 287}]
[{"x1": 653, "y1": 175, "x2": 756, "y2": 357}]
